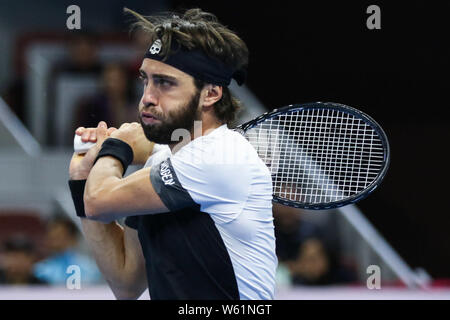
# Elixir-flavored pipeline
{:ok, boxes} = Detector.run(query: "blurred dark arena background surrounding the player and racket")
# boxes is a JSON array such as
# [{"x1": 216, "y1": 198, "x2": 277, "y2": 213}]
[{"x1": 0, "y1": 0, "x2": 450, "y2": 299}]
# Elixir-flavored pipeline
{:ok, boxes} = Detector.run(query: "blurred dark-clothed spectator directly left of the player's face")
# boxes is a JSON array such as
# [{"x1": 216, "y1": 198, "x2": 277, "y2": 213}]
[{"x1": 71, "y1": 63, "x2": 137, "y2": 136}]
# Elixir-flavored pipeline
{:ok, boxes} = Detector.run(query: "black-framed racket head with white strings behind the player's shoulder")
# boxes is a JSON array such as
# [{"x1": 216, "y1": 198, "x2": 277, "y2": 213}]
[{"x1": 236, "y1": 102, "x2": 390, "y2": 210}]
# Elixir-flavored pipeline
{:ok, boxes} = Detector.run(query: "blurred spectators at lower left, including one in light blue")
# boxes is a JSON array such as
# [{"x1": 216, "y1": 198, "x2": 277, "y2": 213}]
[{"x1": 0, "y1": 213, "x2": 103, "y2": 286}]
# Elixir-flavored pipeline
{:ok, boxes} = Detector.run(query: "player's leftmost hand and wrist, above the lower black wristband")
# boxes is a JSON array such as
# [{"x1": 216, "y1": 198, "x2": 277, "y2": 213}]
[{"x1": 69, "y1": 121, "x2": 117, "y2": 180}]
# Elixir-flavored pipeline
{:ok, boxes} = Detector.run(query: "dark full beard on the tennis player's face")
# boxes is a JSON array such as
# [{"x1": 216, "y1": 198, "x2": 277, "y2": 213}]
[{"x1": 139, "y1": 90, "x2": 200, "y2": 144}]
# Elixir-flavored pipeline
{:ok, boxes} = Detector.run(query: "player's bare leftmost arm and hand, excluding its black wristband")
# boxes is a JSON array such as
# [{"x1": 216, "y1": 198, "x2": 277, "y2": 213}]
[{"x1": 69, "y1": 123, "x2": 147, "y2": 299}]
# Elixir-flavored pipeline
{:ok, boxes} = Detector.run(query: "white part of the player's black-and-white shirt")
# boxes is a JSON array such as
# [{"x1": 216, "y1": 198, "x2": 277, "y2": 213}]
[{"x1": 137, "y1": 125, "x2": 278, "y2": 299}]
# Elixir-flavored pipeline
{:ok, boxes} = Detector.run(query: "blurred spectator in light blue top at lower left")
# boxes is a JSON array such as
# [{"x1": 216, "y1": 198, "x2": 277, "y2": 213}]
[{"x1": 34, "y1": 215, "x2": 102, "y2": 285}]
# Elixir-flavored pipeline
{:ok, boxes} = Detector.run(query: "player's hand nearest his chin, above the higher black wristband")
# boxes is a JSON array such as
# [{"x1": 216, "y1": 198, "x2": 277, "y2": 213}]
[{"x1": 110, "y1": 122, "x2": 155, "y2": 165}]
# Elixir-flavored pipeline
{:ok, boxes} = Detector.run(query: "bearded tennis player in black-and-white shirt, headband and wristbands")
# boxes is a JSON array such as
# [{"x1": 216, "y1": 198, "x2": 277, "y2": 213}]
[{"x1": 69, "y1": 9, "x2": 277, "y2": 300}]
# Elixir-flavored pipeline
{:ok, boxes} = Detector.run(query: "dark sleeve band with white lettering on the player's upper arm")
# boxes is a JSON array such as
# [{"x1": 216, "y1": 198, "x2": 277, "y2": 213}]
[{"x1": 150, "y1": 158, "x2": 198, "y2": 211}]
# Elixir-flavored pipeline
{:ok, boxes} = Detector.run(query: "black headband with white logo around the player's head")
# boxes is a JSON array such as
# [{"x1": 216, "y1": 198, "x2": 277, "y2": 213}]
[{"x1": 144, "y1": 39, "x2": 247, "y2": 86}]
